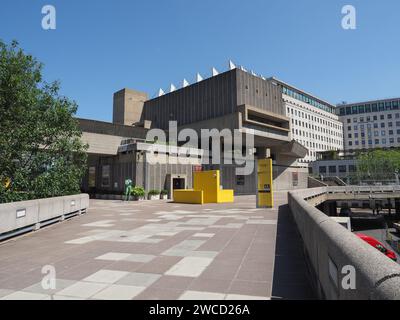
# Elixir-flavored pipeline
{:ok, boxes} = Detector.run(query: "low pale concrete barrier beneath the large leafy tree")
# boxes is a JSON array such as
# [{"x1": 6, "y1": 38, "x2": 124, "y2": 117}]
[{"x1": 0, "y1": 194, "x2": 89, "y2": 241}]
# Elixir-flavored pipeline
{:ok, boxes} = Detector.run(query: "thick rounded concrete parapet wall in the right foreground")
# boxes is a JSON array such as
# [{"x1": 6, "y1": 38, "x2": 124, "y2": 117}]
[{"x1": 288, "y1": 187, "x2": 400, "y2": 300}]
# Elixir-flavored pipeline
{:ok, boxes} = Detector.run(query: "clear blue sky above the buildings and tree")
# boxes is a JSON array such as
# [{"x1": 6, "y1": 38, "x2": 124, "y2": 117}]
[{"x1": 0, "y1": 0, "x2": 400, "y2": 121}]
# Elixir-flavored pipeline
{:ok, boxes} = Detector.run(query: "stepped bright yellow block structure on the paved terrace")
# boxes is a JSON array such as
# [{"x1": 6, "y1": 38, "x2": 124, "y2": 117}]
[{"x1": 174, "y1": 170, "x2": 234, "y2": 204}]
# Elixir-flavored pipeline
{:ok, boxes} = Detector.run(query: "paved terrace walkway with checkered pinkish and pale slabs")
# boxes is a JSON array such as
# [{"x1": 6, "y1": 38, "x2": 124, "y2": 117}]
[{"x1": 0, "y1": 193, "x2": 314, "y2": 300}]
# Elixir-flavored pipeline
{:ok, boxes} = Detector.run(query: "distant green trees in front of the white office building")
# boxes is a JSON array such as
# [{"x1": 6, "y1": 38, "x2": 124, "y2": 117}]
[{"x1": 357, "y1": 149, "x2": 400, "y2": 181}]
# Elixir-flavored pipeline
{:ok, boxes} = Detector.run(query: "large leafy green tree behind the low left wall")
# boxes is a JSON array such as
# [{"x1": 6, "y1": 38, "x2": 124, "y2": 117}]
[{"x1": 0, "y1": 40, "x2": 87, "y2": 203}]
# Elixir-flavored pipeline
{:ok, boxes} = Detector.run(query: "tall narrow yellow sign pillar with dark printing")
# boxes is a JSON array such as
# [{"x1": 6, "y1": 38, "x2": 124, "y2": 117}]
[{"x1": 257, "y1": 159, "x2": 274, "y2": 208}]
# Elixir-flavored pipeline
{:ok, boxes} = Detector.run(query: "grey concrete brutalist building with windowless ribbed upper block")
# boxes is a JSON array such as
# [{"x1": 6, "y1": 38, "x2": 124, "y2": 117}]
[{"x1": 79, "y1": 68, "x2": 308, "y2": 194}]
